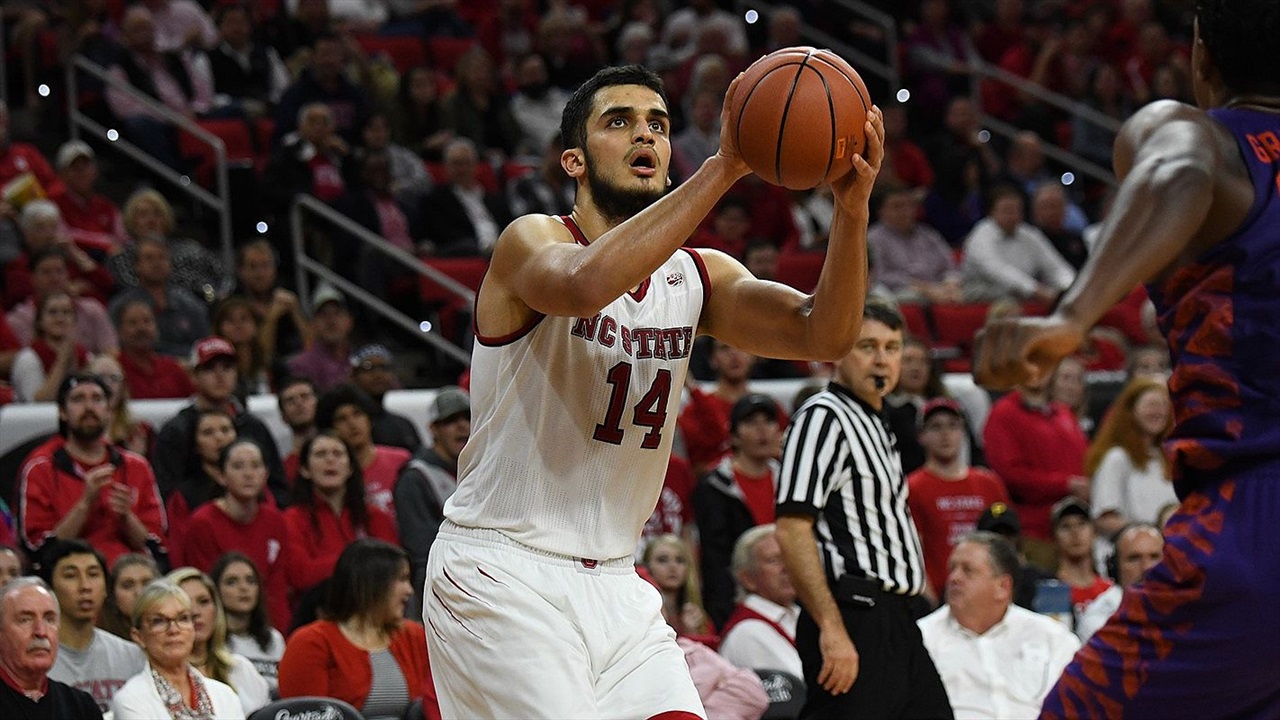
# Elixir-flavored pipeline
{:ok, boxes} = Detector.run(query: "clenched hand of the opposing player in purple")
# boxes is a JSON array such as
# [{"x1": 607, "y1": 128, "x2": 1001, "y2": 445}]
[{"x1": 973, "y1": 315, "x2": 1084, "y2": 389}]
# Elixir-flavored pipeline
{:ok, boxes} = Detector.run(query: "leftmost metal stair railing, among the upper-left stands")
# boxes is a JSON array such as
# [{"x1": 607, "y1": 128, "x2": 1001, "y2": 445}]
[{"x1": 67, "y1": 55, "x2": 236, "y2": 268}]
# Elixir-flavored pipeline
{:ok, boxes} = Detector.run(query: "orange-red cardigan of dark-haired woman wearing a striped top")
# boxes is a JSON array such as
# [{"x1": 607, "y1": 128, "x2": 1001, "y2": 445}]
[{"x1": 279, "y1": 620, "x2": 440, "y2": 720}]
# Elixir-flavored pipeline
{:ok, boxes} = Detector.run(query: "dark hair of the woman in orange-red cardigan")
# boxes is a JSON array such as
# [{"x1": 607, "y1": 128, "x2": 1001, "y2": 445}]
[{"x1": 324, "y1": 538, "x2": 410, "y2": 623}]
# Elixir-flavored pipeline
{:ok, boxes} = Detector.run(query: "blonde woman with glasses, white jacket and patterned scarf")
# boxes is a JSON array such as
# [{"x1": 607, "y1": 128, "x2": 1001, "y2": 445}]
[{"x1": 111, "y1": 580, "x2": 244, "y2": 720}]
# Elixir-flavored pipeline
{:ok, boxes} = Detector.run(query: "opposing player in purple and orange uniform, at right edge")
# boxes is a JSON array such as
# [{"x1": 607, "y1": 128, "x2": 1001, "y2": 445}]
[{"x1": 975, "y1": 0, "x2": 1280, "y2": 719}]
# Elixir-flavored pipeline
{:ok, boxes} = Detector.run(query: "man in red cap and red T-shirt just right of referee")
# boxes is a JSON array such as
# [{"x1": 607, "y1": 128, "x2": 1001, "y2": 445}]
[{"x1": 906, "y1": 397, "x2": 1009, "y2": 598}]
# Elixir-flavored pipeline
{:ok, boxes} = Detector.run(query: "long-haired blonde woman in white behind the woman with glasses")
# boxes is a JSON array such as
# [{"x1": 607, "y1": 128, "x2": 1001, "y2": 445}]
[{"x1": 165, "y1": 568, "x2": 271, "y2": 715}]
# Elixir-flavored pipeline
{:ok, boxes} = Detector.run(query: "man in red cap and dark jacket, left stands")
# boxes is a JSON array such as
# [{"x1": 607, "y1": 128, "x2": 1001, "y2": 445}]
[{"x1": 154, "y1": 336, "x2": 288, "y2": 505}]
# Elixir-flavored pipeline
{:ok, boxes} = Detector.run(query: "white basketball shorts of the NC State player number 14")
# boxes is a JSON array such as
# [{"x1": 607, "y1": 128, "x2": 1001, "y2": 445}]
[{"x1": 422, "y1": 520, "x2": 705, "y2": 719}]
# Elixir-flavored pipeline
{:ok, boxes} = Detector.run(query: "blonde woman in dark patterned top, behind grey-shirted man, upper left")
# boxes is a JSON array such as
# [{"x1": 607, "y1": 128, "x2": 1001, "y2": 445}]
[{"x1": 108, "y1": 188, "x2": 232, "y2": 302}]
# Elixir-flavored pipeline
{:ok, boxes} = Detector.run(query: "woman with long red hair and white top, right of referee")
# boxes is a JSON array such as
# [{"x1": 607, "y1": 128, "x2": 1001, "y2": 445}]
[{"x1": 1084, "y1": 377, "x2": 1178, "y2": 536}]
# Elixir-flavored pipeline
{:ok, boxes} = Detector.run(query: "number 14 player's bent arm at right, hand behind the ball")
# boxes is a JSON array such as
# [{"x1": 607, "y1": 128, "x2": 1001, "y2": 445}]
[{"x1": 703, "y1": 106, "x2": 884, "y2": 360}]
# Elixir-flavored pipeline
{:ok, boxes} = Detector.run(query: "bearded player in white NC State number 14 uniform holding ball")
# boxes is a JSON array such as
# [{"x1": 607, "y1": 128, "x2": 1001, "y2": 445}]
[{"x1": 424, "y1": 65, "x2": 883, "y2": 719}]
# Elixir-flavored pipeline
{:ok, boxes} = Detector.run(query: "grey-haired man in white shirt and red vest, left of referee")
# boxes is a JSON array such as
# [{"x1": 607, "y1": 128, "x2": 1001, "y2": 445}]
[{"x1": 719, "y1": 523, "x2": 804, "y2": 678}]
